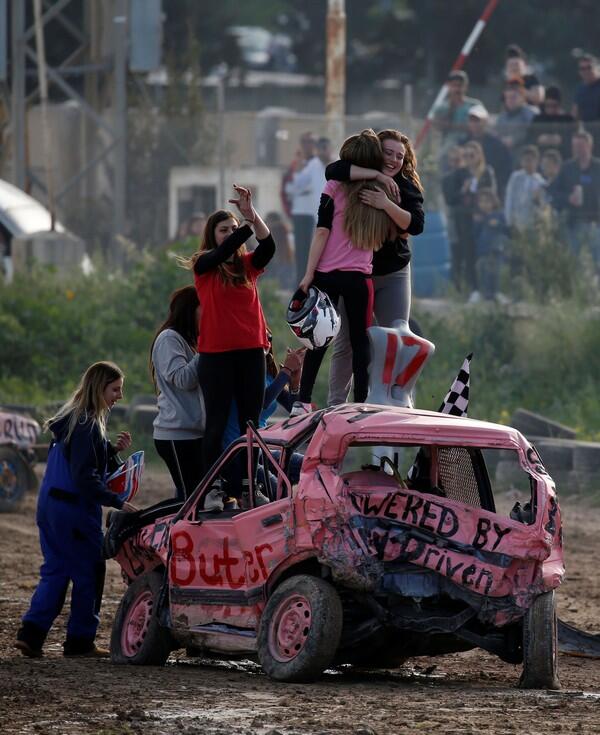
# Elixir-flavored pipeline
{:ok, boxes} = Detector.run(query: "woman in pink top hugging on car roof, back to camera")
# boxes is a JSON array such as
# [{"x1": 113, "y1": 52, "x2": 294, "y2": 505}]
[{"x1": 292, "y1": 129, "x2": 394, "y2": 415}]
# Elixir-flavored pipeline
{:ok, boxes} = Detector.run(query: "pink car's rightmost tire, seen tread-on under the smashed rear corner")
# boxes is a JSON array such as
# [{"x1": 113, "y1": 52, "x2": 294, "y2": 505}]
[{"x1": 519, "y1": 590, "x2": 560, "y2": 689}]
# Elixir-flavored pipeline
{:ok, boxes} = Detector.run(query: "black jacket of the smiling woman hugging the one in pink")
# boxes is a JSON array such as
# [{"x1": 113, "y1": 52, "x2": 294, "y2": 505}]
[{"x1": 325, "y1": 161, "x2": 425, "y2": 276}]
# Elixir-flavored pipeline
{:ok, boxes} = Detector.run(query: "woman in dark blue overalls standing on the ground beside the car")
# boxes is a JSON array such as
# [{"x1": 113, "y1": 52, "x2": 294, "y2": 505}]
[{"x1": 15, "y1": 362, "x2": 133, "y2": 657}]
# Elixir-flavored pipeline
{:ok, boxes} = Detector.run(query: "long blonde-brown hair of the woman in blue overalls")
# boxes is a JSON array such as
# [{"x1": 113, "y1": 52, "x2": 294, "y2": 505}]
[{"x1": 44, "y1": 360, "x2": 124, "y2": 442}]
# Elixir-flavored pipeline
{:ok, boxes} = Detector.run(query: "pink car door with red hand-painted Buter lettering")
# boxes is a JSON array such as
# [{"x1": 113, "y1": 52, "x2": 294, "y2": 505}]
[{"x1": 169, "y1": 434, "x2": 293, "y2": 630}]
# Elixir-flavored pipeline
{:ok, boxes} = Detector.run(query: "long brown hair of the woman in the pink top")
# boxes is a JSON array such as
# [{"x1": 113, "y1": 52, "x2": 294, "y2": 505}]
[{"x1": 340, "y1": 128, "x2": 393, "y2": 250}]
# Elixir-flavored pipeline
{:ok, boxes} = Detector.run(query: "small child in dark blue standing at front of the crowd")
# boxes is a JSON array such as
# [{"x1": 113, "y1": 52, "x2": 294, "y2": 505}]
[{"x1": 473, "y1": 189, "x2": 509, "y2": 304}]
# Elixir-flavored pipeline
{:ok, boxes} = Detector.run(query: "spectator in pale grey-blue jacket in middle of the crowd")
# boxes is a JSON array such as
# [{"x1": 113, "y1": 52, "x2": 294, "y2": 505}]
[{"x1": 504, "y1": 145, "x2": 545, "y2": 232}]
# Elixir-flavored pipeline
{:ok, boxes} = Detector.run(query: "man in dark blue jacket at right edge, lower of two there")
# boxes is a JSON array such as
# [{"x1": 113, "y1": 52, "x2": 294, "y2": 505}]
[{"x1": 548, "y1": 130, "x2": 600, "y2": 267}]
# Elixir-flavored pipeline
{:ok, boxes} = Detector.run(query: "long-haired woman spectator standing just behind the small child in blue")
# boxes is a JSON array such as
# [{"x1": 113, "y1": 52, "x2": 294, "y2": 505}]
[{"x1": 456, "y1": 141, "x2": 498, "y2": 303}]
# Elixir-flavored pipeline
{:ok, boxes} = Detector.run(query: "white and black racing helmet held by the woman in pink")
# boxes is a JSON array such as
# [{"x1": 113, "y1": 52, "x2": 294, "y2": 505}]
[{"x1": 287, "y1": 286, "x2": 340, "y2": 350}]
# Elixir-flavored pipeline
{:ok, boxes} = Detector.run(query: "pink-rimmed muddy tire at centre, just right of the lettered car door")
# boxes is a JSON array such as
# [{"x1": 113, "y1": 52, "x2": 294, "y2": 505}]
[{"x1": 258, "y1": 574, "x2": 343, "y2": 682}]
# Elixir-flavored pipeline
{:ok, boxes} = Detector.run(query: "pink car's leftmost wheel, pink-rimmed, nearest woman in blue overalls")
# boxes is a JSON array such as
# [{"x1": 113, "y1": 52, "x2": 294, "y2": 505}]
[{"x1": 110, "y1": 571, "x2": 174, "y2": 666}]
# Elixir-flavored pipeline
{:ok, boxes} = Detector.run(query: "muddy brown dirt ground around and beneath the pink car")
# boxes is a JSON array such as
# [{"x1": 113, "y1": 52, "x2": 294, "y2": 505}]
[{"x1": 0, "y1": 470, "x2": 600, "y2": 735}]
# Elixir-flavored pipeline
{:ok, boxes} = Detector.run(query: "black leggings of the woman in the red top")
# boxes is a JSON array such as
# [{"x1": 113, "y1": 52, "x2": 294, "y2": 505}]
[{"x1": 198, "y1": 347, "x2": 265, "y2": 473}]
